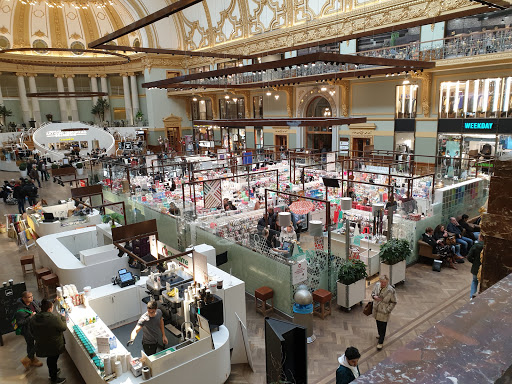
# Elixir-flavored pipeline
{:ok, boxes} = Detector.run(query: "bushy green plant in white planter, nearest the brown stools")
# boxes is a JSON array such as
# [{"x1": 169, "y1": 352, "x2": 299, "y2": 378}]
[{"x1": 336, "y1": 259, "x2": 368, "y2": 311}]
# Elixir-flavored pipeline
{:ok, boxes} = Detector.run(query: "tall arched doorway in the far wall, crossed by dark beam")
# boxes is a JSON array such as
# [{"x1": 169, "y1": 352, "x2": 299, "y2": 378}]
[{"x1": 306, "y1": 96, "x2": 333, "y2": 152}]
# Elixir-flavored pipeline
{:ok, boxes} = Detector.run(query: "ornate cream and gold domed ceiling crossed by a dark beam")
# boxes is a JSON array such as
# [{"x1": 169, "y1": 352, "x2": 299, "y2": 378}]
[{"x1": 0, "y1": 0, "x2": 387, "y2": 55}]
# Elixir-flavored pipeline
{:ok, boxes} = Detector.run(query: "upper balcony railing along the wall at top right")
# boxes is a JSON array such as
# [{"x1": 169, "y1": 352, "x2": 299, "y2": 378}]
[{"x1": 357, "y1": 28, "x2": 512, "y2": 61}]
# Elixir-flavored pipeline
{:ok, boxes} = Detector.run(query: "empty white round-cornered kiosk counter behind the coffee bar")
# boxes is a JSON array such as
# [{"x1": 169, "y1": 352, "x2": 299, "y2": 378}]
[{"x1": 36, "y1": 224, "x2": 128, "y2": 290}]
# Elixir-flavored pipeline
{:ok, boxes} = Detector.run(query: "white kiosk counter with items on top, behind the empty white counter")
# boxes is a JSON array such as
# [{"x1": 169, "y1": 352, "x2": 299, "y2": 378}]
[{"x1": 27, "y1": 202, "x2": 101, "y2": 237}]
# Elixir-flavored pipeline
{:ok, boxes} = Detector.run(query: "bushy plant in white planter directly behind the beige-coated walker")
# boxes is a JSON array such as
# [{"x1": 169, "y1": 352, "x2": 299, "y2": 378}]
[{"x1": 379, "y1": 239, "x2": 412, "y2": 285}]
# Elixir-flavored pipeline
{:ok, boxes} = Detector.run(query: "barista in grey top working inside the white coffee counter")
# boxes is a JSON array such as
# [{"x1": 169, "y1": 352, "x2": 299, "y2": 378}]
[{"x1": 127, "y1": 301, "x2": 168, "y2": 356}]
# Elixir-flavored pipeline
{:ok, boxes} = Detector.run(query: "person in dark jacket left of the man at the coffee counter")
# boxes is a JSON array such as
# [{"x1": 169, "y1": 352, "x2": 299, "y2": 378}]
[{"x1": 14, "y1": 291, "x2": 43, "y2": 369}]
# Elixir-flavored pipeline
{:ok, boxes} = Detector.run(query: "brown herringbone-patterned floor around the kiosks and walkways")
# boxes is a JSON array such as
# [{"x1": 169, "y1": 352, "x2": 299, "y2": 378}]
[{"x1": 0, "y1": 172, "x2": 471, "y2": 384}]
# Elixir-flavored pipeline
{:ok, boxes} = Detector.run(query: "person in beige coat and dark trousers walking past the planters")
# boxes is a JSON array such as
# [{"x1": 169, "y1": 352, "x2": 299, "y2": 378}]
[{"x1": 372, "y1": 275, "x2": 397, "y2": 351}]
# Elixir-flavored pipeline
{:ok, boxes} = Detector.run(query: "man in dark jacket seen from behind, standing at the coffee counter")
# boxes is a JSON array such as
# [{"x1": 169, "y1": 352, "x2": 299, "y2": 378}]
[{"x1": 30, "y1": 299, "x2": 67, "y2": 384}]
